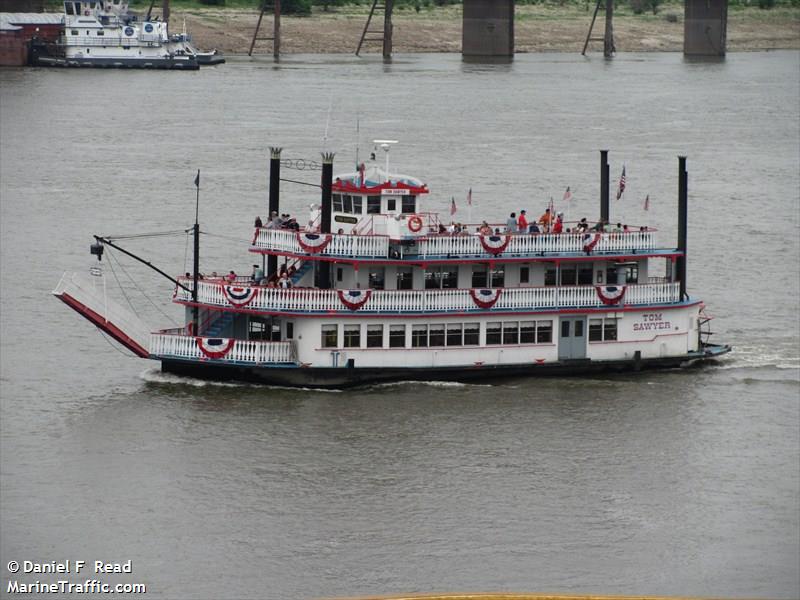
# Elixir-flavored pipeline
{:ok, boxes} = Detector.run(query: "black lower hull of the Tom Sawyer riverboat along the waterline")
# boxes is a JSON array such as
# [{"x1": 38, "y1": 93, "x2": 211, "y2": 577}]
[{"x1": 161, "y1": 345, "x2": 731, "y2": 388}]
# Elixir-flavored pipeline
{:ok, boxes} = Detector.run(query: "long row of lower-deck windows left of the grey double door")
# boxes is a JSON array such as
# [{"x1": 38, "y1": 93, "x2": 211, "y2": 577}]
[{"x1": 322, "y1": 320, "x2": 553, "y2": 348}]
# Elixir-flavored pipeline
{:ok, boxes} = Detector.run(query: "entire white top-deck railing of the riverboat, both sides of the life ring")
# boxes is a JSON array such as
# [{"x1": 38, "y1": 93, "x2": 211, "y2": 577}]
[{"x1": 253, "y1": 228, "x2": 655, "y2": 258}]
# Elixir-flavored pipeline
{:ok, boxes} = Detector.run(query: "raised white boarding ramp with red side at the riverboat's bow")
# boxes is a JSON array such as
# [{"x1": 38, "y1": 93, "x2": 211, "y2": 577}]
[{"x1": 53, "y1": 272, "x2": 151, "y2": 358}]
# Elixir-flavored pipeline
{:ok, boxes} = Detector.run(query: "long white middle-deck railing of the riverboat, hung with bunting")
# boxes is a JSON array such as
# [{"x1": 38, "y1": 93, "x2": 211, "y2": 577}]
[{"x1": 175, "y1": 281, "x2": 680, "y2": 314}]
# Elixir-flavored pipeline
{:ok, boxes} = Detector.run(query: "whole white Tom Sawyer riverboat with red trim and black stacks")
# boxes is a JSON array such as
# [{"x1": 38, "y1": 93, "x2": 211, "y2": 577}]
[{"x1": 53, "y1": 146, "x2": 731, "y2": 388}]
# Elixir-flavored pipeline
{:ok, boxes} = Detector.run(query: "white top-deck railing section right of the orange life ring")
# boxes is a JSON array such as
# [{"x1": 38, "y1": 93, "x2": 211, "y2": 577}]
[{"x1": 419, "y1": 231, "x2": 655, "y2": 258}]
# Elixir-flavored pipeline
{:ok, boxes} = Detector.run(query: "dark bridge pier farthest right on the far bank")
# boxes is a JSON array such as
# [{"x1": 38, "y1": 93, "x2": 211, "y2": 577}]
[{"x1": 683, "y1": 0, "x2": 728, "y2": 56}]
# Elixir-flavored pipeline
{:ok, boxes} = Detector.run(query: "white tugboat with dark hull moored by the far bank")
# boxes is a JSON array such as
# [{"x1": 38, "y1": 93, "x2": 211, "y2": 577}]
[{"x1": 29, "y1": 0, "x2": 225, "y2": 71}]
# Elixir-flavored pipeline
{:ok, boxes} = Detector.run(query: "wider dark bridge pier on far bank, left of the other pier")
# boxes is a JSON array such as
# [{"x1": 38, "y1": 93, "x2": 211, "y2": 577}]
[{"x1": 461, "y1": 0, "x2": 514, "y2": 58}]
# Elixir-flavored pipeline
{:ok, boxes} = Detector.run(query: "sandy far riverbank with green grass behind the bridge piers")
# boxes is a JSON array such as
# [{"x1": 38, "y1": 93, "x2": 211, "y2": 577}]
[{"x1": 175, "y1": 4, "x2": 800, "y2": 56}]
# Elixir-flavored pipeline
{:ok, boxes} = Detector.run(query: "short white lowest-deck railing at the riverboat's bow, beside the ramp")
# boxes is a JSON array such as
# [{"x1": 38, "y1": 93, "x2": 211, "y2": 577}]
[{"x1": 150, "y1": 333, "x2": 296, "y2": 364}]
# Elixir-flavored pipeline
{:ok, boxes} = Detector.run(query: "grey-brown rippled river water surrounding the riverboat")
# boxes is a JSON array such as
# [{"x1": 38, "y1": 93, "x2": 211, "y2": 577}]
[{"x1": 0, "y1": 52, "x2": 800, "y2": 599}]
